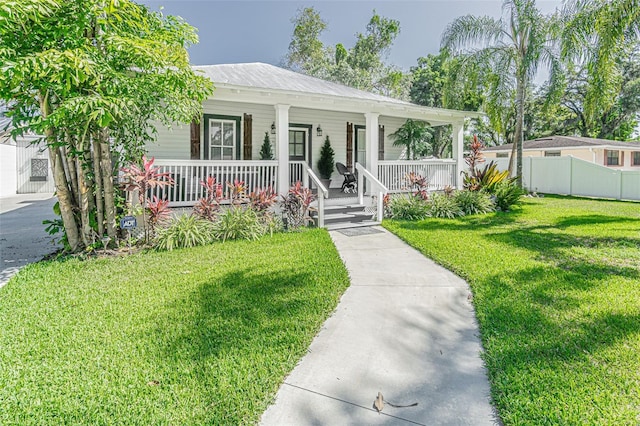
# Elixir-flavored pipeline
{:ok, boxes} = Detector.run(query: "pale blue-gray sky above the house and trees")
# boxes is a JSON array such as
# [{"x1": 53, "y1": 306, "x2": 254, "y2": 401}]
[{"x1": 137, "y1": 0, "x2": 562, "y2": 71}]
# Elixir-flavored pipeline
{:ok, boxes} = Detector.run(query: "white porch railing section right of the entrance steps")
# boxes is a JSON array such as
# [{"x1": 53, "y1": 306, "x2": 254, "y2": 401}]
[{"x1": 378, "y1": 159, "x2": 457, "y2": 192}]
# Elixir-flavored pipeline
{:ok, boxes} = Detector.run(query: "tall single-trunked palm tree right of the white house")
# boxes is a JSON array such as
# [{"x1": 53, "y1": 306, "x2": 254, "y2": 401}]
[{"x1": 441, "y1": 0, "x2": 560, "y2": 186}]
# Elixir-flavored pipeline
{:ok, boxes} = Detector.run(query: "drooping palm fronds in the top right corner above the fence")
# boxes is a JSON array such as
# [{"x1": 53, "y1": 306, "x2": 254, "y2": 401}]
[{"x1": 562, "y1": 0, "x2": 640, "y2": 130}]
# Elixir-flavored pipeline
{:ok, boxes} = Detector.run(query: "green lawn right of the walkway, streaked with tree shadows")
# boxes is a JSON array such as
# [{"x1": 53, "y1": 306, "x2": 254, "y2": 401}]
[{"x1": 384, "y1": 197, "x2": 640, "y2": 425}]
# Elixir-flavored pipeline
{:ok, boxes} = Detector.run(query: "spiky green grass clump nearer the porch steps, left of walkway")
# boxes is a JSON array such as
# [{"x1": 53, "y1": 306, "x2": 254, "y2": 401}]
[{"x1": 213, "y1": 206, "x2": 266, "y2": 242}]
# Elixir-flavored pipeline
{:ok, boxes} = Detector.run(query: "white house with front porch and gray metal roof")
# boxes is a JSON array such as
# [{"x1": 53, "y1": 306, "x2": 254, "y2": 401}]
[{"x1": 147, "y1": 63, "x2": 475, "y2": 205}]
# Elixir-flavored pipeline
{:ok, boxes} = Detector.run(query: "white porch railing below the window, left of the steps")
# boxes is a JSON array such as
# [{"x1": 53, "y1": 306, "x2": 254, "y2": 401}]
[{"x1": 152, "y1": 160, "x2": 278, "y2": 207}]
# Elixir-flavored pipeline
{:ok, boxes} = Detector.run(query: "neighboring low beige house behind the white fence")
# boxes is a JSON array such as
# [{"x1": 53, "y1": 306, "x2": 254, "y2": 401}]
[{"x1": 484, "y1": 136, "x2": 640, "y2": 170}]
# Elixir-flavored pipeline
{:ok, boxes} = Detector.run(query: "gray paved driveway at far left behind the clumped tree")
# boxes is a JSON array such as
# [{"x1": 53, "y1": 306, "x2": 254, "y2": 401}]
[{"x1": 0, "y1": 194, "x2": 58, "y2": 287}]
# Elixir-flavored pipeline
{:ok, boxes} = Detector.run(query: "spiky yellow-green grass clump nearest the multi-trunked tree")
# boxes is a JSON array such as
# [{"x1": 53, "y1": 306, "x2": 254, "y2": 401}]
[{"x1": 154, "y1": 214, "x2": 215, "y2": 251}]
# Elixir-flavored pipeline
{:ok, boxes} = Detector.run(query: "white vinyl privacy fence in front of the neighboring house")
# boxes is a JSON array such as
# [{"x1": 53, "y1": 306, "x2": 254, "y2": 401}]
[{"x1": 487, "y1": 156, "x2": 640, "y2": 200}]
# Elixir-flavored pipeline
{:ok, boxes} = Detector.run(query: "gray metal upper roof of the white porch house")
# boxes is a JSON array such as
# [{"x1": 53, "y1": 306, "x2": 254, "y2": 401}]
[{"x1": 193, "y1": 62, "x2": 415, "y2": 105}]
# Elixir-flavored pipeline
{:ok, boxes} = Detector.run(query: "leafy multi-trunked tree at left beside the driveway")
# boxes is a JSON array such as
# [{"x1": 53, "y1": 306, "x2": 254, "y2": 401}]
[{"x1": 0, "y1": 0, "x2": 212, "y2": 250}]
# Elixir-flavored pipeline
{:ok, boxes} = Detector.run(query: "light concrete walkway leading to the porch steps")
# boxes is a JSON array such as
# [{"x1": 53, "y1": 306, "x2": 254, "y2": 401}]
[{"x1": 261, "y1": 227, "x2": 500, "y2": 426}]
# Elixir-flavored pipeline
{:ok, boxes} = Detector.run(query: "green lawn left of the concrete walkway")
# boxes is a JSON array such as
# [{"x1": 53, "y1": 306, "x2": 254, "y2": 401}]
[{"x1": 0, "y1": 230, "x2": 348, "y2": 425}]
